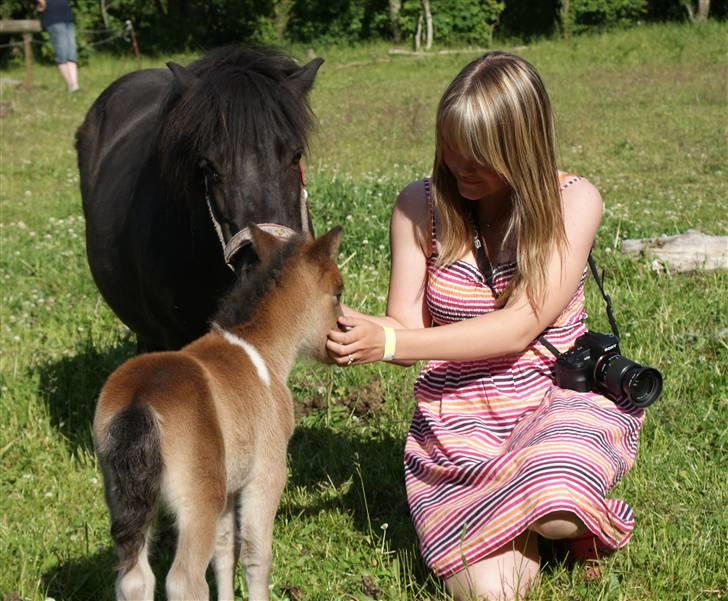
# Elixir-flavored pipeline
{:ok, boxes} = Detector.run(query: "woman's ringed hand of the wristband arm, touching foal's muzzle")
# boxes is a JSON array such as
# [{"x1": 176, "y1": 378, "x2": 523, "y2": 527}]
[{"x1": 326, "y1": 316, "x2": 384, "y2": 367}]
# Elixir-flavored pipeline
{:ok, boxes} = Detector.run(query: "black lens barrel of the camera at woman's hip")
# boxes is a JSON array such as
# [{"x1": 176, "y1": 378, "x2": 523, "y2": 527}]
[{"x1": 594, "y1": 353, "x2": 662, "y2": 408}]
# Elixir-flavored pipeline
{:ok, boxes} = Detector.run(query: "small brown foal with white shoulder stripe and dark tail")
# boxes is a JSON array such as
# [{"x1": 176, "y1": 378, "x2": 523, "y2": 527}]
[{"x1": 94, "y1": 228, "x2": 342, "y2": 601}]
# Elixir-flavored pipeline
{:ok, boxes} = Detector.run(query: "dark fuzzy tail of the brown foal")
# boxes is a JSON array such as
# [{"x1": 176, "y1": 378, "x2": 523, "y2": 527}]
[{"x1": 99, "y1": 403, "x2": 163, "y2": 573}]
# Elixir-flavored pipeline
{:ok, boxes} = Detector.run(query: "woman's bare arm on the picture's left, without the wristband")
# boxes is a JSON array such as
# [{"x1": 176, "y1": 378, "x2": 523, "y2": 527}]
[{"x1": 329, "y1": 181, "x2": 430, "y2": 365}]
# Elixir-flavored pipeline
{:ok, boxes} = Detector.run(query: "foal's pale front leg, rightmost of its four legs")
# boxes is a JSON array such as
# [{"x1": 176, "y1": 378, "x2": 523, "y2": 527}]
[{"x1": 240, "y1": 448, "x2": 286, "y2": 601}]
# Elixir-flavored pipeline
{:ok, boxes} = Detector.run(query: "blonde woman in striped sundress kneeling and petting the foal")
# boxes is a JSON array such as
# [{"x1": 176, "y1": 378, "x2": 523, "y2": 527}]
[{"x1": 328, "y1": 52, "x2": 643, "y2": 600}]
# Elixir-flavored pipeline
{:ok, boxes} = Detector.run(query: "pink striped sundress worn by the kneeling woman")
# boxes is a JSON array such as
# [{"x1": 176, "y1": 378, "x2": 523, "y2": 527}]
[{"x1": 404, "y1": 177, "x2": 643, "y2": 578}]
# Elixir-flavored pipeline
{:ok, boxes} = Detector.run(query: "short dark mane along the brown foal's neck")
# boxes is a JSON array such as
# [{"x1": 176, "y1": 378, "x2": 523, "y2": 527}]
[{"x1": 213, "y1": 235, "x2": 304, "y2": 329}]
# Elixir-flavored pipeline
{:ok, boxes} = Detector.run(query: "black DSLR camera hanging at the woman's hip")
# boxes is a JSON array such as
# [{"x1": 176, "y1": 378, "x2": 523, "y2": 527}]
[{"x1": 556, "y1": 332, "x2": 662, "y2": 409}]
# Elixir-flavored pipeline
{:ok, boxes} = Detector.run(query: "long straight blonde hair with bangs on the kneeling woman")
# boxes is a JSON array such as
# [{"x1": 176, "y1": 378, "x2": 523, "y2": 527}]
[{"x1": 432, "y1": 51, "x2": 567, "y2": 310}]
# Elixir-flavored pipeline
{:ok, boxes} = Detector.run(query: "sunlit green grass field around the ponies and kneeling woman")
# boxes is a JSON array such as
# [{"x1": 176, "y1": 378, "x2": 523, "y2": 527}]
[{"x1": 0, "y1": 23, "x2": 728, "y2": 601}]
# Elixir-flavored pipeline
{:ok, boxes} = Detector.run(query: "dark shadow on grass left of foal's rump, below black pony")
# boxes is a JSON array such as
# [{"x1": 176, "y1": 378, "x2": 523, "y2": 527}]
[{"x1": 39, "y1": 340, "x2": 136, "y2": 453}]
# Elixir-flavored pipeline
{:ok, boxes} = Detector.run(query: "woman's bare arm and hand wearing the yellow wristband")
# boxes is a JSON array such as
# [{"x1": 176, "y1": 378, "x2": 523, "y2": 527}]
[{"x1": 330, "y1": 180, "x2": 602, "y2": 363}]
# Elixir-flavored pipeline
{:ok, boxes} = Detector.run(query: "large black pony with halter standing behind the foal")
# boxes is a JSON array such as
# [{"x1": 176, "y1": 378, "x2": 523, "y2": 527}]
[{"x1": 76, "y1": 47, "x2": 323, "y2": 350}]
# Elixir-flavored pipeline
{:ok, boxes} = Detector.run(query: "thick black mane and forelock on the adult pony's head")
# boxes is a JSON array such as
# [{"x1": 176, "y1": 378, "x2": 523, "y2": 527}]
[{"x1": 158, "y1": 46, "x2": 313, "y2": 194}]
